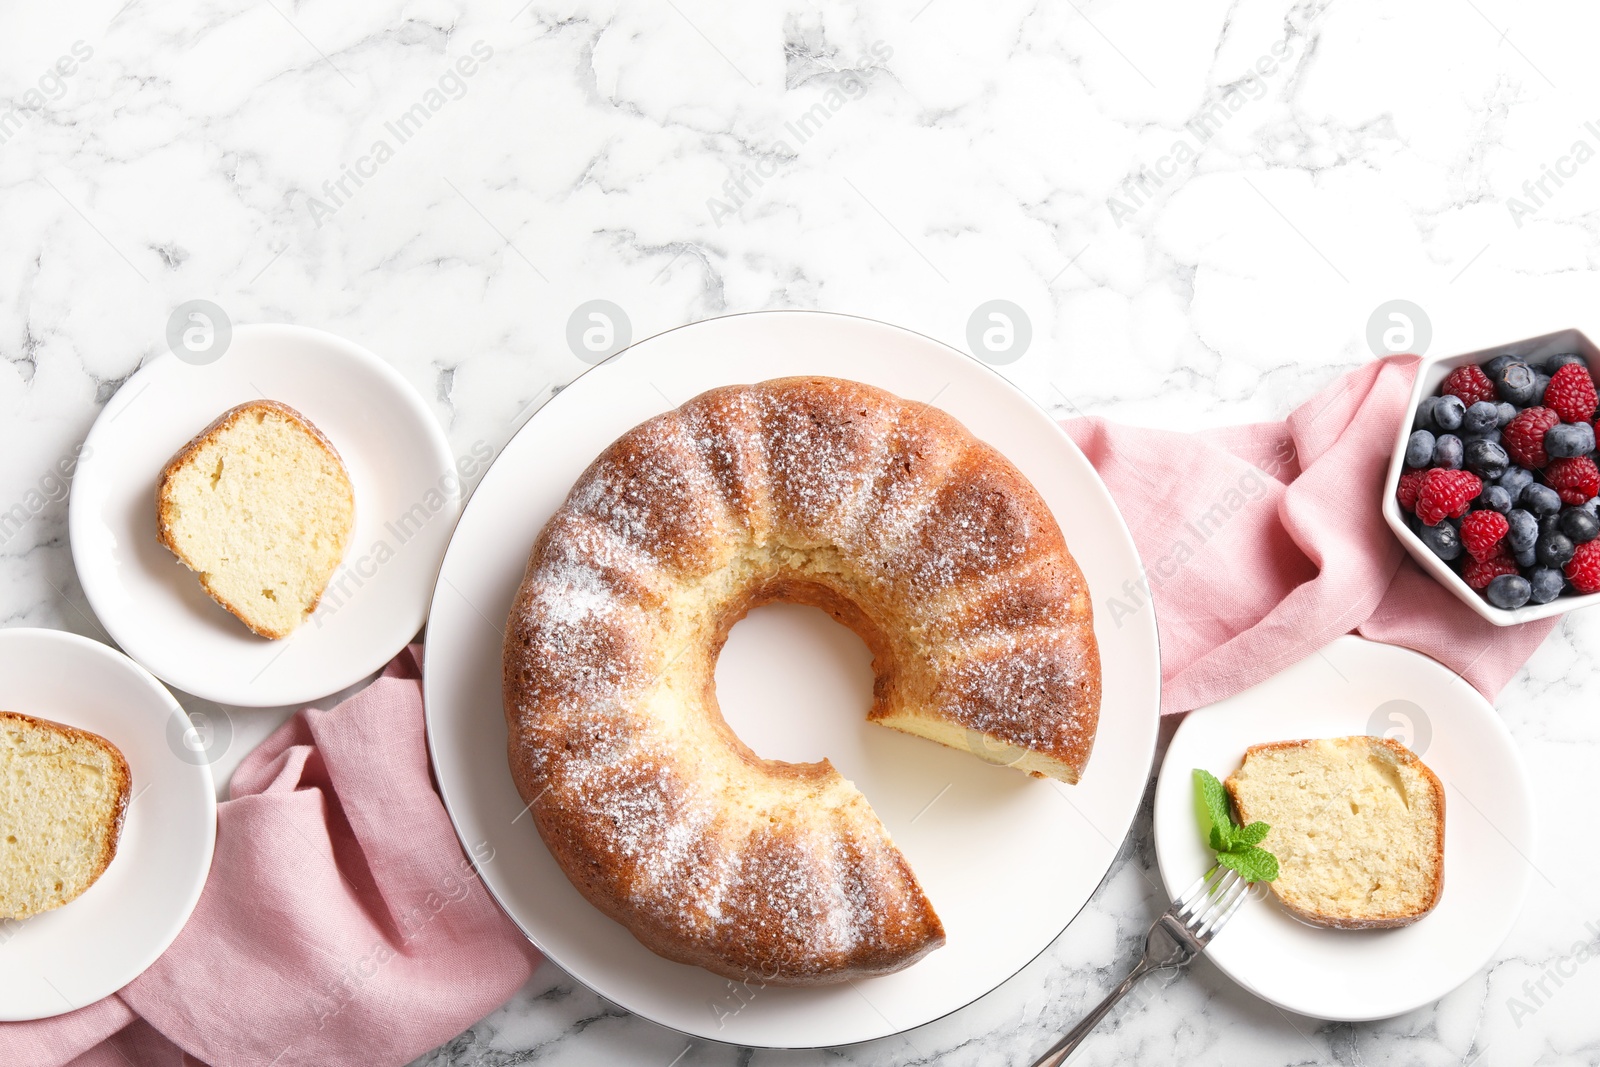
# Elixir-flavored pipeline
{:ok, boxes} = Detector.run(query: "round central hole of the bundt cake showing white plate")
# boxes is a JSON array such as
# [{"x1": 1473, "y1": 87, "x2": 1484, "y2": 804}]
[{"x1": 717, "y1": 603, "x2": 872, "y2": 765}]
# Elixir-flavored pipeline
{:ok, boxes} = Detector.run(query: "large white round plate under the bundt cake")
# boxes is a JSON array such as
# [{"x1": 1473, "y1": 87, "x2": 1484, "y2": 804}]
[{"x1": 424, "y1": 312, "x2": 1160, "y2": 1048}]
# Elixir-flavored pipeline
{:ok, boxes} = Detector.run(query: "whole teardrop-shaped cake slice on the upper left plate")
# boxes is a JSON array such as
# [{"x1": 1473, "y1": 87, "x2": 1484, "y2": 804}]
[{"x1": 157, "y1": 400, "x2": 355, "y2": 638}]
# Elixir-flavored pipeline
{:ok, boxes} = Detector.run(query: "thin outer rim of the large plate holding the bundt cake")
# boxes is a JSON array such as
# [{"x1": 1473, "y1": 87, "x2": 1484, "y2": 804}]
[{"x1": 422, "y1": 309, "x2": 1163, "y2": 1051}]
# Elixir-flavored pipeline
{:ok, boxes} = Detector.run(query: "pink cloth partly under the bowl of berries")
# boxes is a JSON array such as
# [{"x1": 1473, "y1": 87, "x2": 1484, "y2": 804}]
[{"x1": 1062, "y1": 355, "x2": 1555, "y2": 715}]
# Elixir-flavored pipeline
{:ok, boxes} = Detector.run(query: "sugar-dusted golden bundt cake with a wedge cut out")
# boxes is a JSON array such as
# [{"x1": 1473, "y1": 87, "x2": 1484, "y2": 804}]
[{"x1": 504, "y1": 378, "x2": 1101, "y2": 985}]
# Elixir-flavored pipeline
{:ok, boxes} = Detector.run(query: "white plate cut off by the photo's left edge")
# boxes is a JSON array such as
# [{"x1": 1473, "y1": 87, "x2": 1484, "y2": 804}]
[{"x1": 0, "y1": 629, "x2": 216, "y2": 1022}]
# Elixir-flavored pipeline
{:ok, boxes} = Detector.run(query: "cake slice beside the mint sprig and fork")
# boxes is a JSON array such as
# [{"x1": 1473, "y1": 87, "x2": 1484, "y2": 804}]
[{"x1": 1227, "y1": 736, "x2": 1445, "y2": 929}]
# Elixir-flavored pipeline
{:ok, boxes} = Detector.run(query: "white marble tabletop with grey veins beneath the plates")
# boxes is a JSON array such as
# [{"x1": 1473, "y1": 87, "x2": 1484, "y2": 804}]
[{"x1": 0, "y1": 0, "x2": 1600, "y2": 1067}]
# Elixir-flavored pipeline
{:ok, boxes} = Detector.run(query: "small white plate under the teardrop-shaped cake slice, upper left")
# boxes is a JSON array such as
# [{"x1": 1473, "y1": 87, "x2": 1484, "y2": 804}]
[{"x1": 69, "y1": 325, "x2": 461, "y2": 707}]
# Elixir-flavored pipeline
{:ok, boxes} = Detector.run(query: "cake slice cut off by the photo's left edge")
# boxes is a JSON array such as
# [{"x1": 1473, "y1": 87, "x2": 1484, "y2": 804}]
[{"x1": 0, "y1": 712, "x2": 131, "y2": 918}]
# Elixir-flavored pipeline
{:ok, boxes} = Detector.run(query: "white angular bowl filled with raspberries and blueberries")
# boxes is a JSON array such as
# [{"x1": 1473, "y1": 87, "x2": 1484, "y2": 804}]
[{"x1": 1384, "y1": 330, "x2": 1600, "y2": 625}]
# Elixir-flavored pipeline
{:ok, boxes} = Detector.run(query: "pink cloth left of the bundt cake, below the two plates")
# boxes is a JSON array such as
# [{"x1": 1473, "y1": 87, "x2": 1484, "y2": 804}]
[{"x1": 0, "y1": 648, "x2": 538, "y2": 1067}]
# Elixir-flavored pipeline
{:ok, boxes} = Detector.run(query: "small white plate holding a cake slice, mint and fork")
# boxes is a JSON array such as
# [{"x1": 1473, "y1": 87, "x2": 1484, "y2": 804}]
[{"x1": 1155, "y1": 637, "x2": 1534, "y2": 1022}]
